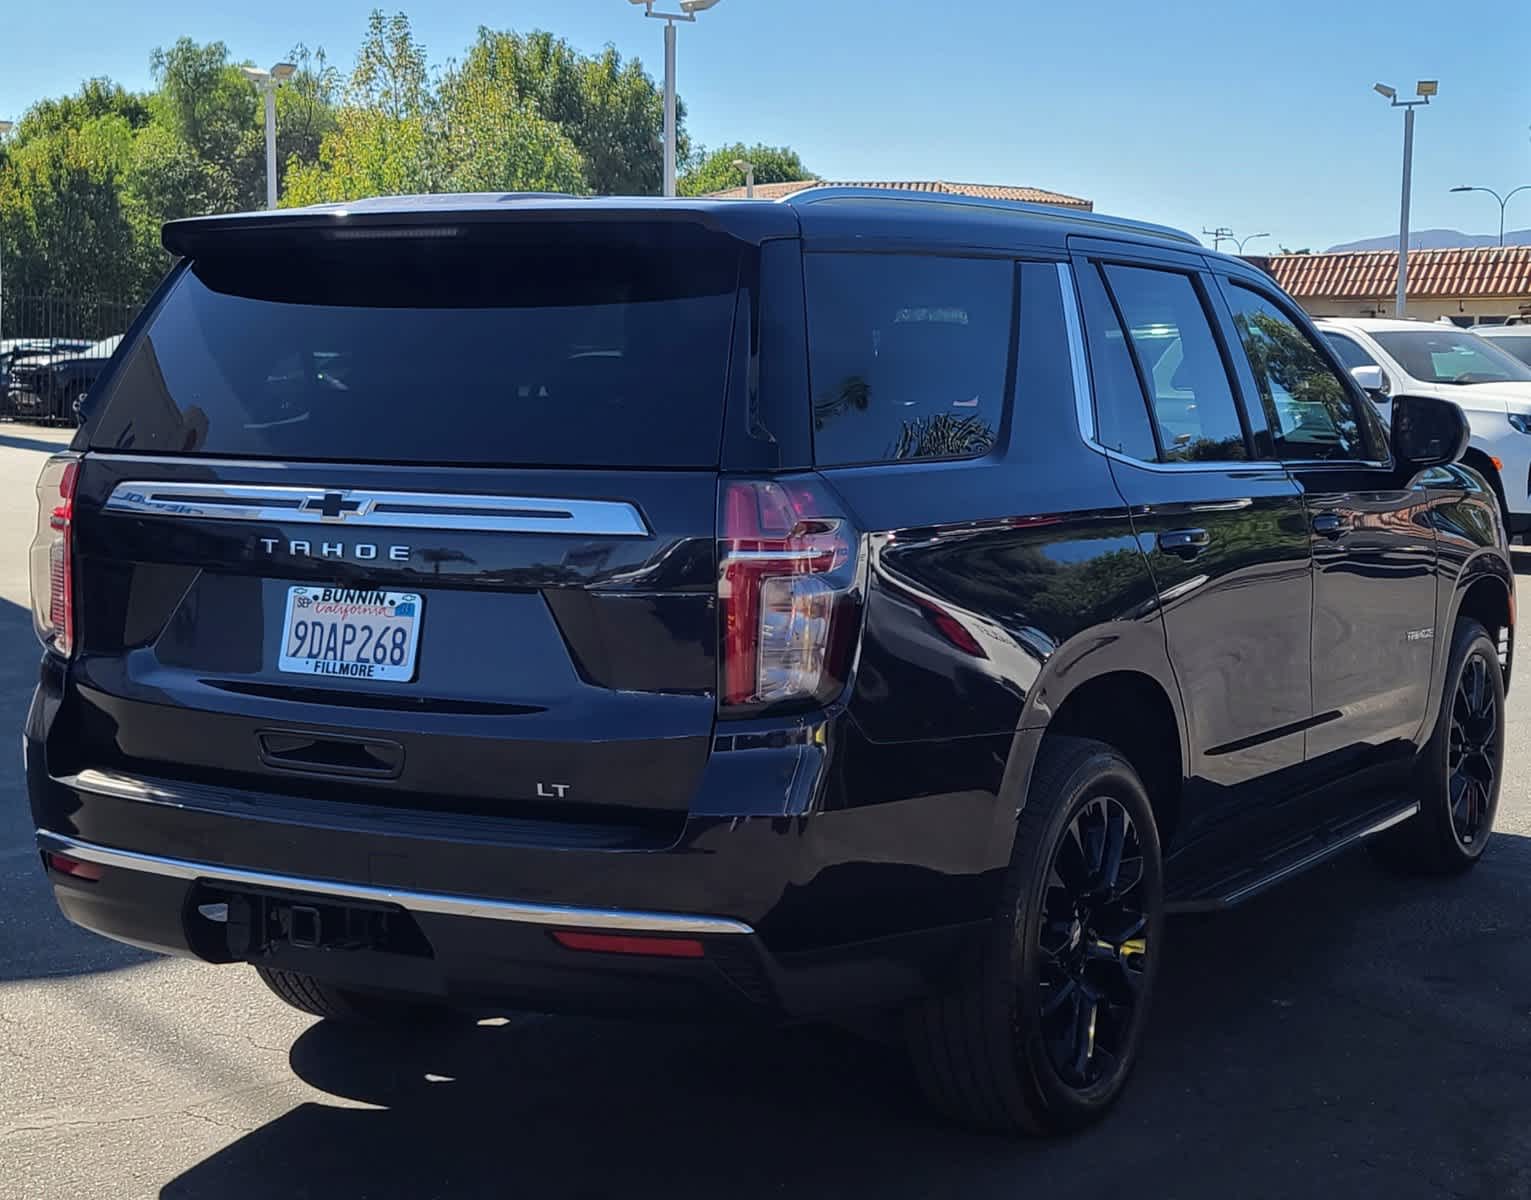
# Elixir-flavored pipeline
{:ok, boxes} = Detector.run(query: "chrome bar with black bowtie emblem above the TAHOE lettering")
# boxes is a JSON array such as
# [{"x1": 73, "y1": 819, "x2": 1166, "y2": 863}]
[{"x1": 104, "y1": 481, "x2": 649, "y2": 537}]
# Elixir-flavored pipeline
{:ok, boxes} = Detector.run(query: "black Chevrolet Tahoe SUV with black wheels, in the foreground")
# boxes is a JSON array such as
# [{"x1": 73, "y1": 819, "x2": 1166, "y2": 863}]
[{"x1": 26, "y1": 187, "x2": 1514, "y2": 1133}]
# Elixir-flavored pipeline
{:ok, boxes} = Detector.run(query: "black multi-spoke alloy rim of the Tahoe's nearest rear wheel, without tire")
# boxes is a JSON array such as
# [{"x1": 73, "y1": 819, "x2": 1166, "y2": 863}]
[{"x1": 1038, "y1": 796, "x2": 1148, "y2": 1090}]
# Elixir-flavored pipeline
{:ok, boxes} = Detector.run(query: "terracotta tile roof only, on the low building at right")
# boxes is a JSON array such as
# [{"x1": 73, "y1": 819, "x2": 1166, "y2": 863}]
[{"x1": 1262, "y1": 246, "x2": 1531, "y2": 300}]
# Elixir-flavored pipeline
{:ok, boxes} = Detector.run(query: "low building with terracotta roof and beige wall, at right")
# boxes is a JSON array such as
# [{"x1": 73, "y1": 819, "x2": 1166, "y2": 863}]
[{"x1": 1249, "y1": 246, "x2": 1531, "y2": 324}]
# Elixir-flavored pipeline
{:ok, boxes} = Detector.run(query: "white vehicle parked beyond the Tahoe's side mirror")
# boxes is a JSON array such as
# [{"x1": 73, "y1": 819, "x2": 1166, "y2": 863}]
[{"x1": 1315, "y1": 317, "x2": 1531, "y2": 537}]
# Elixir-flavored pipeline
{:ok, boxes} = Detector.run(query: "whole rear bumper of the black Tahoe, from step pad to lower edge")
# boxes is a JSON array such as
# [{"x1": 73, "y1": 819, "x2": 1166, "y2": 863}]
[{"x1": 26, "y1": 707, "x2": 1009, "y2": 1019}]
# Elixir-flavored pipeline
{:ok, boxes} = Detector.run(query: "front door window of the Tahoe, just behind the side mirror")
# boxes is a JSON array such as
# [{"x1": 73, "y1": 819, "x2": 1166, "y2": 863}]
[{"x1": 1228, "y1": 283, "x2": 1369, "y2": 459}]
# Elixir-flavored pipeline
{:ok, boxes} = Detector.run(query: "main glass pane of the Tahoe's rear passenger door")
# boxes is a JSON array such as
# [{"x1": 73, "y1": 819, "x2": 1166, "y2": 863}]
[{"x1": 1105, "y1": 266, "x2": 1249, "y2": 462}]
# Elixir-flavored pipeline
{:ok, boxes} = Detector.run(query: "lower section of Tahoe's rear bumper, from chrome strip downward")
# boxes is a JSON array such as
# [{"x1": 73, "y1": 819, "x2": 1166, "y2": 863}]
[{"x1": 37, "y1": 831, "x2": 986, "y2": 1019}]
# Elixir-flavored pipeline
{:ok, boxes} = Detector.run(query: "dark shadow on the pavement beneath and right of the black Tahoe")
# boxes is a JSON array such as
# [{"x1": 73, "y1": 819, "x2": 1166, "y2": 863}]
[{"x1": 162, "y1": 834, "x2": 1531, "y2": 1200}]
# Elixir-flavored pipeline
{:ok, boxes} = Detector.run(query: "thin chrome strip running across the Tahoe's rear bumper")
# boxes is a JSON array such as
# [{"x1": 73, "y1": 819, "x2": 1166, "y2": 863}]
[{"x1": 37, "y1": 830, "x2": 755, "y2": 935}]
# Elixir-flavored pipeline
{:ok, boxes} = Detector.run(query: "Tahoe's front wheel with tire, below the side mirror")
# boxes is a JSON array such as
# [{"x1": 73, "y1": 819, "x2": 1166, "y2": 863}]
[{"x1": 1369, "y1": 617, "x2": 1505, "y2": 876}]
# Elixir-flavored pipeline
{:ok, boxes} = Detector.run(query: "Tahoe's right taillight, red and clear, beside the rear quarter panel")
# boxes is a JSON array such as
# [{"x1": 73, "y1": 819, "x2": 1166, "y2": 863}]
[{"x1": 718, "y1": 479, "x2": 860, "y2": 709}]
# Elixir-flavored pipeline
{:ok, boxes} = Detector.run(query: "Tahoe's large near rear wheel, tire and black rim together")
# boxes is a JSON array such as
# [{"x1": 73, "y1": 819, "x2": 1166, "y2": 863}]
[{"x1": 905, "y1": 736, "x2": 1164, "y2": 1136}]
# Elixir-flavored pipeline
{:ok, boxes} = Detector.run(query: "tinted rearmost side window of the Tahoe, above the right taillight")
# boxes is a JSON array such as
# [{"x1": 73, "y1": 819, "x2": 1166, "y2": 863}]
[{"x1": 804, "y1": 254, "x2": 1015, "y2": 465}]
